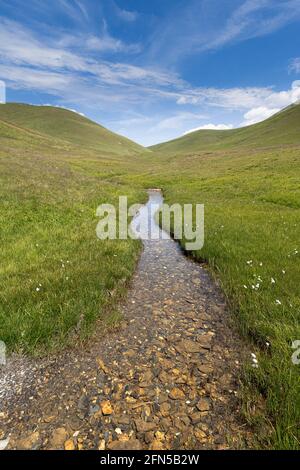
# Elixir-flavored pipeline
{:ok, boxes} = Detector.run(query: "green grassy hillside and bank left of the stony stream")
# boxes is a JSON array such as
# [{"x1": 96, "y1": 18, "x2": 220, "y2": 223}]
[{"x1": 0, "y1": 105, "x2": 149, "y2": 352}]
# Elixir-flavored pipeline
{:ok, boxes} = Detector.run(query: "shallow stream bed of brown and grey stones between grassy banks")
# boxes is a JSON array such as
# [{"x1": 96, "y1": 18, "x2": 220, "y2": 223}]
[{"x1": 0, "y1": 193, "x2": 251, "y2": 450}]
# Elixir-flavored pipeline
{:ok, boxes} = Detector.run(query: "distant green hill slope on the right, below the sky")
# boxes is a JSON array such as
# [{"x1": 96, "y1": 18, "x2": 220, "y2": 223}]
[{"x1": 150, "y1": 104, "x2": 300, "y2": 155}]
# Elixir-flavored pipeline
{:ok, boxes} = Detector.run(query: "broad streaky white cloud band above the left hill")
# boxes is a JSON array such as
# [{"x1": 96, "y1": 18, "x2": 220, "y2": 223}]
[{"x1": 0, "y1": 18, "x2": 184, "y2": 111}]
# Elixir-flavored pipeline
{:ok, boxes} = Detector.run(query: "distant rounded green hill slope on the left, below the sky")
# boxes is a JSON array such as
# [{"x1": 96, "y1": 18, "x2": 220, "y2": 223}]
[{"x1": 0, "y1": 103, "x2": 145, "y2": 155}]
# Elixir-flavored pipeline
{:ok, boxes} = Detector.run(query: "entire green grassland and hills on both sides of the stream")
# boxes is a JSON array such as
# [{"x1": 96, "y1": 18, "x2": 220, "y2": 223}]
[{"x1": 0, "y1": 105, "x2": 300, "y2": 449}]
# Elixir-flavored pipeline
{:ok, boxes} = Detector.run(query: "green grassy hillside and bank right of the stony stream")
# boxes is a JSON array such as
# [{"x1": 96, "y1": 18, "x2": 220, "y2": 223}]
[{"x1": 147, "y1": 106, "x2": 300, "y2": 449}]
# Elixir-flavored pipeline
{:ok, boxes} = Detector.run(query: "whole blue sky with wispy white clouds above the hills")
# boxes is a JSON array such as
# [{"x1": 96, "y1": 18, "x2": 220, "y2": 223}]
[{"x1": 0, "y1": 0, "x2": 300, "y2": 145}]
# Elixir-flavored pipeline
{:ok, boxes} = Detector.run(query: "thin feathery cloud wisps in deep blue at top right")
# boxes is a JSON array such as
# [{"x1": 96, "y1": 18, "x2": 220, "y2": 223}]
[{"x1": 149, "y1": 0, "x2": 300, "y2": 63}]
